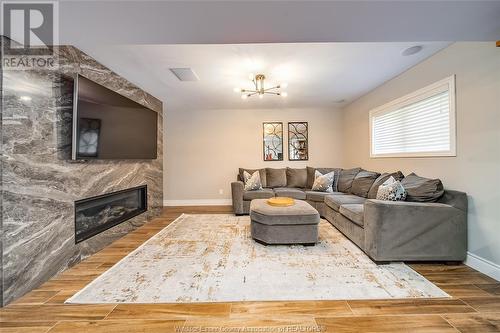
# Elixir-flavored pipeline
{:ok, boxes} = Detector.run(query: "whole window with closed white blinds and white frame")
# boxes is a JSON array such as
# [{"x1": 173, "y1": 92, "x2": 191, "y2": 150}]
[{"x1": 370, "y1": 76, "x2": 456, "y2": 157}]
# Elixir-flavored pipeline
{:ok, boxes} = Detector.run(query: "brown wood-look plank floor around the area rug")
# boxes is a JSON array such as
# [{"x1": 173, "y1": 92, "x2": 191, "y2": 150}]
[{"x1": 0, "y1": 207, "x2": 500, "y2": 333}]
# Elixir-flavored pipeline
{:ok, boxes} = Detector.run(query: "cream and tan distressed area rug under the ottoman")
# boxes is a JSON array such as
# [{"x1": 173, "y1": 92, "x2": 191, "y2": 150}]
[{"x1": 66, "y1": 214, "x2": 449, "y2": 303}]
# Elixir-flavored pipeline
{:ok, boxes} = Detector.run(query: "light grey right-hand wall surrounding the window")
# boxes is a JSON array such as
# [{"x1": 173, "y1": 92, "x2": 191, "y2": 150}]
[{"x1": 343, "y1": 42, "x2": 500, "y2": 279}]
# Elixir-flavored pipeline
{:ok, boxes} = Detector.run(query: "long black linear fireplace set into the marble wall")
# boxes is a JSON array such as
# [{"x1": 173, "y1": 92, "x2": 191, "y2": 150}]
[{"x1": 75, "y1": 185, "x2": 148, "y2": 243}]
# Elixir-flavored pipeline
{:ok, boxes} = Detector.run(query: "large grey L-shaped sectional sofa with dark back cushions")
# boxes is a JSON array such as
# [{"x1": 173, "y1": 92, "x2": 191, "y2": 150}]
[{"x1": 231, "y1": 167, "x2": 467, "y2": 262}]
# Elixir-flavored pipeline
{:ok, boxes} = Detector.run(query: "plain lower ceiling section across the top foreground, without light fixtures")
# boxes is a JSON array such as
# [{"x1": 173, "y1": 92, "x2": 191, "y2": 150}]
[{"x1": 59, "y1": 0, "x2": 500, "y2": 46}]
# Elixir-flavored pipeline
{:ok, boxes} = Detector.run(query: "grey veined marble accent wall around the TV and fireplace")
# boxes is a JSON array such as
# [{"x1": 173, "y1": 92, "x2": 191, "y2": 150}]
[{"x1": 0, "y1": 37, "x2": 163, "y2": 304}]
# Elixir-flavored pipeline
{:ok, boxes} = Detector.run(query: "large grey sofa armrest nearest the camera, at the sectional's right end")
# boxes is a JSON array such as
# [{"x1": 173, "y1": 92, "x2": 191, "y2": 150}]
[{"x1": 364, "y1": 200, "x2": 467, "y2": 261}]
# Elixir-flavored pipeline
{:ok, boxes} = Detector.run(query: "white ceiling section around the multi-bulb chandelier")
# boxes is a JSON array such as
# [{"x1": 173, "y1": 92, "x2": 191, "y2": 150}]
[{"x1": 84, "y1": 42, "x2": 449, "y2": 111}]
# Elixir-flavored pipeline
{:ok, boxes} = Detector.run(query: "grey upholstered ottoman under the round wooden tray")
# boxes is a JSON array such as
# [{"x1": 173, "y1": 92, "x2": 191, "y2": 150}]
[{"x1": 250, "y1": 199, "x2": 320, "y2": 245}]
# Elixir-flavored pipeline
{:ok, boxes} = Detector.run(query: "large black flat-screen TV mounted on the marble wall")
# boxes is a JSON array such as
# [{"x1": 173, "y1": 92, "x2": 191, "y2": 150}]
[{"x1": 72, "y1": 75, "x2": 158, "y2": 159}]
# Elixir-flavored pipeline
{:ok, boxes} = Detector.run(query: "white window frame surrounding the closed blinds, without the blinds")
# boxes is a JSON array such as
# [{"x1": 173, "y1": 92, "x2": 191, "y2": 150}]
[{"x1": 368, "y1": 74, "x2": 457, "y2": 158}]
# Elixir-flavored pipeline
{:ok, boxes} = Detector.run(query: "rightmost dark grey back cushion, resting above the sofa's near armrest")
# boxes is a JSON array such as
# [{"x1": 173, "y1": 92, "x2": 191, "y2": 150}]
[{"x1": 401, "y1": 173, "x2": 444, "y2": 202}]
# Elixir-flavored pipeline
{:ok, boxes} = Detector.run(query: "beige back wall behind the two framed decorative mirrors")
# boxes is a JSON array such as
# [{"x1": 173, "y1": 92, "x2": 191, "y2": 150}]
[{"x1": 164, "y1": 108, "x2": 343, "y2": 205}]
